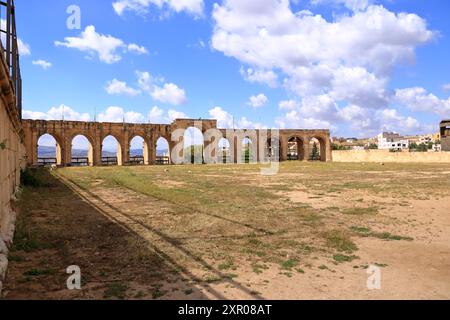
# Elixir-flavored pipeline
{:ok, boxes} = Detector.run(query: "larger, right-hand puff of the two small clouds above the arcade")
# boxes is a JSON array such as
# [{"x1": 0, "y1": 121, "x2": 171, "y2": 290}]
[{"x1": 136, "y1": 71, "x2": 187, "y2": 106}]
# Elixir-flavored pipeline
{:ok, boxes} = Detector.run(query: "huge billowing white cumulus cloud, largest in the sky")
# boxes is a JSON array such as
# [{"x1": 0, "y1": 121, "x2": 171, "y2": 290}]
[{"x1": 211, "y1": 0, "x2": 436, "y2": 135}]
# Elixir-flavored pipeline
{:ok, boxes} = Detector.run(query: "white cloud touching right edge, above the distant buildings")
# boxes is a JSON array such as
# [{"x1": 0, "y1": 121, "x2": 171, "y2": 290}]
[{"x1": 395, "y1": 87, "x2": 450, "y2": 117}]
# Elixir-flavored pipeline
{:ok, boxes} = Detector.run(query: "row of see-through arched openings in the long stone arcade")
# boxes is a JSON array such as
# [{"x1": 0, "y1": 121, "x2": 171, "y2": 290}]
[{"x1": 37, "y1": 127, "x2": 326, "y2": 166}]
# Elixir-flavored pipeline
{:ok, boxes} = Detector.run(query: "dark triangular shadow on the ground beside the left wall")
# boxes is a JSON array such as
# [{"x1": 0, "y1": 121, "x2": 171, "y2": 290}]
[{"x1": 3, "y1": 170, "x2": 211, "y2": 299}]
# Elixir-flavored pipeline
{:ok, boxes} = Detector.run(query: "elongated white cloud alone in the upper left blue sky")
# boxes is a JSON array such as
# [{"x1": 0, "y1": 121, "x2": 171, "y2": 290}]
[{"x1": 55, "y1": 25, "x2": 148, "y2": 64}]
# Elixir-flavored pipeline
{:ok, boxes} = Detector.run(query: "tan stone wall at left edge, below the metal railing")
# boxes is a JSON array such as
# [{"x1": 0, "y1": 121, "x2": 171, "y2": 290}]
[{"x1": 0, "y1": 65, "x2": 26, "y2": 293}]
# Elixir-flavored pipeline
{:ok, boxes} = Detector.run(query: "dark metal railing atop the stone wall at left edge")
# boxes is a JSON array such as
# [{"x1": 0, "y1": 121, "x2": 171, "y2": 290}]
[{"x1": 0, "y1": 0, "x2": 22, "y2": 119}]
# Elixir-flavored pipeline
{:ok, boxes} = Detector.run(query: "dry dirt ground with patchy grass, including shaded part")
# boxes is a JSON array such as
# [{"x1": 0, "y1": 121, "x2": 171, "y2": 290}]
[{"x1": 3, "y1": 162, "x2": 450, "y2": 299}]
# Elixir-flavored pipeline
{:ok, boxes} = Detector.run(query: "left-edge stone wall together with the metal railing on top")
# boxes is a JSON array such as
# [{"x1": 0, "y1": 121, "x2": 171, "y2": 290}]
[{"x1": 0, "y1": 0, "x2": 26, "y2": 293}]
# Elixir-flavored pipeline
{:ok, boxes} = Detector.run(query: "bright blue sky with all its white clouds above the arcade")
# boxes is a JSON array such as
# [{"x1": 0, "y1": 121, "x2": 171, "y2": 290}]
[{"x1": 16, "y1": 0, "x2": 450, "y2": 144}]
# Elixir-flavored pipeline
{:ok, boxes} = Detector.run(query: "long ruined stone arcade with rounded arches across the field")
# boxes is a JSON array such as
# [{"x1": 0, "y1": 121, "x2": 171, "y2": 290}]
[{"x1": 23, "y1": 119, "x2": 332, "y2": 166}]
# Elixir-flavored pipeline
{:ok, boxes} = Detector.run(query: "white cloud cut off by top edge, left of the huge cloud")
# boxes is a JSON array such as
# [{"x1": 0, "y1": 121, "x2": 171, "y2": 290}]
[{"x1": 113, "y1": 0, "x2": 204, "y2": 16}]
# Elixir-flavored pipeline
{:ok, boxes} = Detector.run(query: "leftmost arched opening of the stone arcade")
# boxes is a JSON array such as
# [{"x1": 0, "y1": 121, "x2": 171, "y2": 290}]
[{"x1": 34, "y1": 131, "x2": 64, "y2": 166}]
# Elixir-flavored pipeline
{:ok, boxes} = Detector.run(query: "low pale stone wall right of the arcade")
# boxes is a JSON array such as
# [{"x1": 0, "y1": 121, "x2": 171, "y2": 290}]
[{"x1": 333, "y1": 150, "x2": 450, "y2": 163}]
